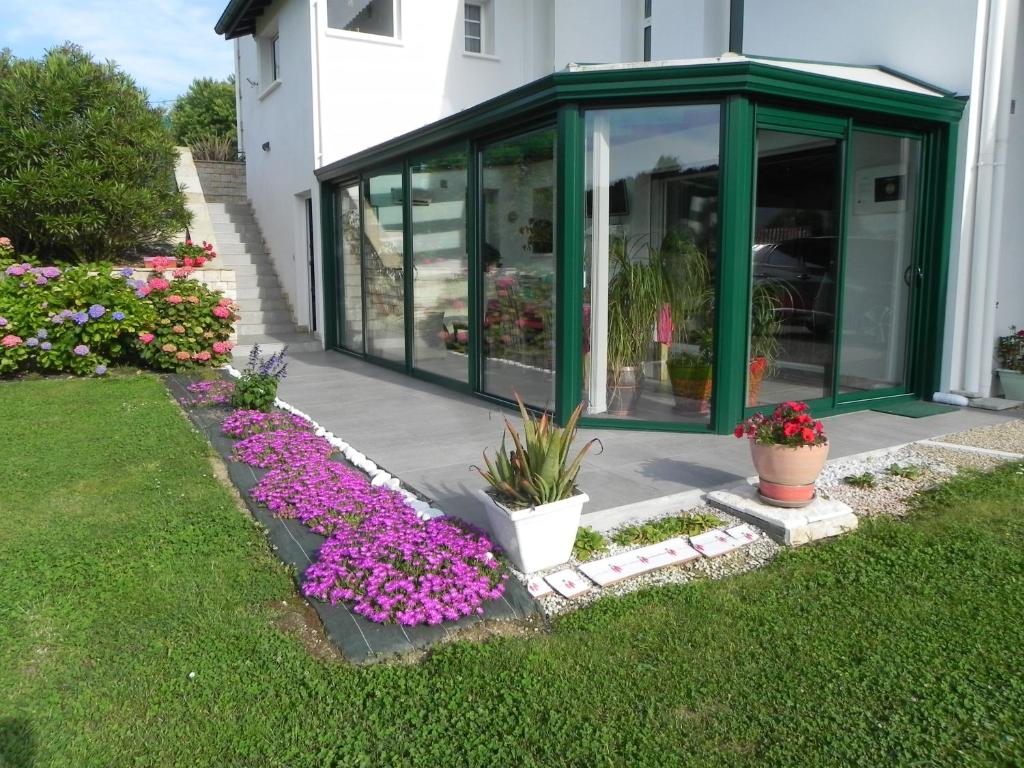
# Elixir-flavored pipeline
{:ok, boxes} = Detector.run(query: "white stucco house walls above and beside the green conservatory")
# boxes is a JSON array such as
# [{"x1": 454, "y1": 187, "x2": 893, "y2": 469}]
[{"x1": 228, "y1": 0, "x2": 1024, "y2": 397}]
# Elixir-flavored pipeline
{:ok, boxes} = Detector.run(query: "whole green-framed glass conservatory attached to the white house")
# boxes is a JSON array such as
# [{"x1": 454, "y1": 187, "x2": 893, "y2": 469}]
[{"x1": 317, "y1": 55, "x2": 963, "y2": 433}]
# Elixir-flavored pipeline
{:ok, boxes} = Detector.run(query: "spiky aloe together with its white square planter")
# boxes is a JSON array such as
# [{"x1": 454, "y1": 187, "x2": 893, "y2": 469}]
[{"x1": 474, "y1": 394, "x2": 598, "y2": 573}]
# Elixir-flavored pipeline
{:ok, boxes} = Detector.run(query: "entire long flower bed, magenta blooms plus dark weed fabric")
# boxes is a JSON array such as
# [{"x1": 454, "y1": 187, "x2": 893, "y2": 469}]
[{"x1": 169, "y1": 377, "x2": 538, "y2": 662}]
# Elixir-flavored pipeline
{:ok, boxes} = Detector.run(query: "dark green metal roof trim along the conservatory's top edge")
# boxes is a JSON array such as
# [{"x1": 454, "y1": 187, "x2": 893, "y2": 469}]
[{"x1": 315, "y1": 59, "x2": 964, "y2": 181}]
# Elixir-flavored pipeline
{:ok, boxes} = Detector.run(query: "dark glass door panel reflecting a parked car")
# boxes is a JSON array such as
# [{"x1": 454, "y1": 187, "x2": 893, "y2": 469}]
[{"x1": 746, "y1": 130, "x2": 841, "y2": 406}]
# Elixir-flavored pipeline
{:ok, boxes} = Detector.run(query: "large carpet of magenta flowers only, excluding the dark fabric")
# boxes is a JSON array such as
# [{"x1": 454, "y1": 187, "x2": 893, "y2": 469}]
[{"x1": 230, "y1": 412, "x2": 508, "y2": 626}]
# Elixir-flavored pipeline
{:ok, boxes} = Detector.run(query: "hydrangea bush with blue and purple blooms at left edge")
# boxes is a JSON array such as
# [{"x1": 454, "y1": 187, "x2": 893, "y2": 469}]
[{"x1": 0, "y1": 262, "x2": 155, "y2": 376}]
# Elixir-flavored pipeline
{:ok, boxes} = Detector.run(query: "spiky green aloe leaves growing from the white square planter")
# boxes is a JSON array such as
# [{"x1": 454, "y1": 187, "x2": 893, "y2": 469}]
[{"x1": 474, "y1": 394, "x2": 600, "y2": 507}]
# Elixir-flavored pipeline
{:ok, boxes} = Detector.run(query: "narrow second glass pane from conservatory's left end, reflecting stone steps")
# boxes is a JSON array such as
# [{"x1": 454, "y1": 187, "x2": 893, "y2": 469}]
[{"x1": 362, "y1": 173, "x2": 406, "y2": 362}]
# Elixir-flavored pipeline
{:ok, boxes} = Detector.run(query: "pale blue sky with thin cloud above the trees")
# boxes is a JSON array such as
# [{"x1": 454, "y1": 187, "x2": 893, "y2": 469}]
[{"x1": 0, "y1": 0, "x2": 234, "y2": 106}]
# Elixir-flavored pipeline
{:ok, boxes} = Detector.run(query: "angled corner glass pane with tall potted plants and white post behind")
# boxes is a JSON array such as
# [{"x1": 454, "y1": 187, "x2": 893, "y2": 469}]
[{"x1": 582, "y1": 105, "x2": 720, "y2": 423}]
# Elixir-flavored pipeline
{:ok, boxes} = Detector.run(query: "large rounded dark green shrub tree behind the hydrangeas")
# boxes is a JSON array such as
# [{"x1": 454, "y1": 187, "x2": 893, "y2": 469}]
[{"x1": 0, "y1": 48, "x2": 188, "y2": 261}]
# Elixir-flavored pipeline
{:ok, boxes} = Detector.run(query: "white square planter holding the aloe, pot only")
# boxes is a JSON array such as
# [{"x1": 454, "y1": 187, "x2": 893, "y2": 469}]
[{"x1": 476, "y1": 490, "x2": 590, "y2": 573}]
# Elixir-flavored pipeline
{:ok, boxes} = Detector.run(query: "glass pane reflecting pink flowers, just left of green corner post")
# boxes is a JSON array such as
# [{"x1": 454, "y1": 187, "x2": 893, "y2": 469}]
[{"x1": 480, "y1": 130, "x2": 555, "y2": 409}]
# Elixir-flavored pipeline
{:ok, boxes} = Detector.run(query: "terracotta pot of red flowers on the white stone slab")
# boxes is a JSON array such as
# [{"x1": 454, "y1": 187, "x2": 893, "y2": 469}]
[{"x1": 733, "y1": 400, "x2": 828, "y2": 507}]
